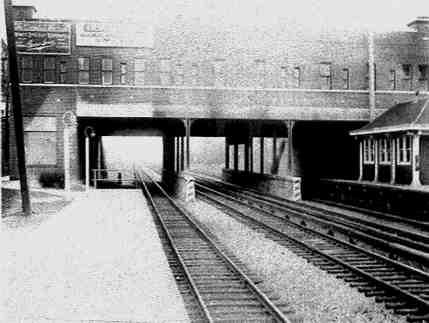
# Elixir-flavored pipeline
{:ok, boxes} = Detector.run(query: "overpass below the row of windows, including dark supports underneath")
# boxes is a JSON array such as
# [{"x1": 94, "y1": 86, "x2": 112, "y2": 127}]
[{"x1": 15, "y1": 84, "x2": 428, "y2": 197}]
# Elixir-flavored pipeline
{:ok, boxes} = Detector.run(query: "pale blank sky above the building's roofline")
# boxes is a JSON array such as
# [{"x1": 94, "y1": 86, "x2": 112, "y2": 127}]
[{"x1": 0, "y1": 0, "x2": 429, "y2": 34}]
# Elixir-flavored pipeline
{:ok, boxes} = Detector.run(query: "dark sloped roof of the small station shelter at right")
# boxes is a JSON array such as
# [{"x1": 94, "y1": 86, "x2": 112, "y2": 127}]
[{"x1": 350, "y1": 98, "x2": 429, "y2": 136}]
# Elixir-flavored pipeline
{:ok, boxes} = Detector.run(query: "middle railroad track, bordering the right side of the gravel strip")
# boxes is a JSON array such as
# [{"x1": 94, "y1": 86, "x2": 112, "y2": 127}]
[{"x1": 193, "y1": 182, "x2": 429, "y2": 322}]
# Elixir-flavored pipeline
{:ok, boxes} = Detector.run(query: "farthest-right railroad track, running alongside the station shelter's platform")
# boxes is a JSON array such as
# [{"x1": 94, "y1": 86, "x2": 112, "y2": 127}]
[{"x1": 192, "y1": 173, "x2": 429, "y2": 268}]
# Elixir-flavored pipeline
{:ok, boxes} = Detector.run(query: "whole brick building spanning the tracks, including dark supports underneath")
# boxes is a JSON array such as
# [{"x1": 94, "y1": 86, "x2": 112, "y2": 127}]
[{"x1": 2, "y1": 6, "x2": 429, "y2": 197}]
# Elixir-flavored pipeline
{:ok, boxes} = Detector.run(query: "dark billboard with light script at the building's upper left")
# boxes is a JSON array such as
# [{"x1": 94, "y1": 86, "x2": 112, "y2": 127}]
[{"x1": 15, "y1": 21, "x2": 70, "y2": 55}]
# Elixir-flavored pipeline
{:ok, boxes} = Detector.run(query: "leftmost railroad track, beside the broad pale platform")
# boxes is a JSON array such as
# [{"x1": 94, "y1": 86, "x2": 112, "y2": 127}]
[{"x1": 139, "y1": 174, "x2": 298, "y2": 323}]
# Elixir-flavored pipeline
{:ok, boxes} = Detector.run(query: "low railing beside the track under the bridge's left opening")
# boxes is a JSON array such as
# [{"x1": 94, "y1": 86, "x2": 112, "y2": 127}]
[{"x1": 92, "y1": 169, "x2": 138, "y2": 189}]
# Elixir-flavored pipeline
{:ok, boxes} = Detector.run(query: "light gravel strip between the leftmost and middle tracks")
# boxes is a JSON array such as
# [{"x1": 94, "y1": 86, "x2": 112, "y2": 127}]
[{"x1": 186, "y1": 201, "x2": 406, "y2": 323}]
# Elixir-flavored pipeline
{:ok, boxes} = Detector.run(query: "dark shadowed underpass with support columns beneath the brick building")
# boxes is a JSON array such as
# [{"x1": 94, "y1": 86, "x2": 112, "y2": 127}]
[{"x1": 73, "y1": 118, "x2": 362, "y2": 200}]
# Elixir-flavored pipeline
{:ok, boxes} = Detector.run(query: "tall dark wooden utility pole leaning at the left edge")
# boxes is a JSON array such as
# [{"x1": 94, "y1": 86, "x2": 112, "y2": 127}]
[{"x1": 4, "y1": 0, "x2": 31, "y2": 215}]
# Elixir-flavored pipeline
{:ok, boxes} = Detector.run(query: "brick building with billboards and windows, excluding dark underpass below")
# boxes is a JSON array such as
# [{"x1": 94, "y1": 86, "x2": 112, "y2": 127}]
[{"x1": 3, "y1": 6, "x2": 429, "y2": 189}]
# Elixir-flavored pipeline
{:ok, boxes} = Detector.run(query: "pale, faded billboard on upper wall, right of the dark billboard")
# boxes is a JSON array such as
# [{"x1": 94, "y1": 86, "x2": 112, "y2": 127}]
[{"x1": 76, "y1": 22, "x2": 153, "y2": 48}]
